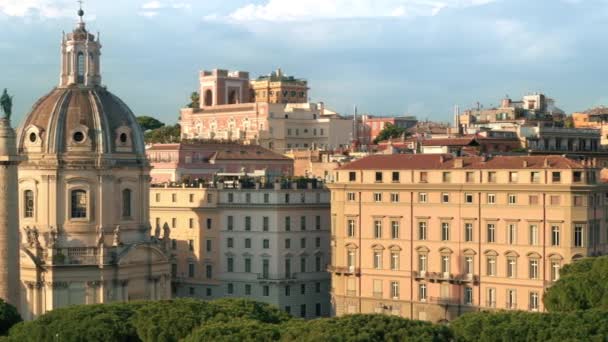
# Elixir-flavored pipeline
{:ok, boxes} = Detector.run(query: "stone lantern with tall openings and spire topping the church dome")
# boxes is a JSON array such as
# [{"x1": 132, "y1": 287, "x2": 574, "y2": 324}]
[{"x1": 59, "y1": 1, "x2": 101, "y2": 88}]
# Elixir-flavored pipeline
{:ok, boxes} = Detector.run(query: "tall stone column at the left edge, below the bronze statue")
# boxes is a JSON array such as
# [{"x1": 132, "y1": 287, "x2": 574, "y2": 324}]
[{"x1": 0, "y1": 117, "x2": 21, "y2": 309}]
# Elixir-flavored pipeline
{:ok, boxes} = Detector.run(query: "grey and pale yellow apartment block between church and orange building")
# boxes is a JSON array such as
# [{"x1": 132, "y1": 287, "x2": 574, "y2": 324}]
[{"x1": 150, "y1": 182, "x2": 331, "y2": 318}]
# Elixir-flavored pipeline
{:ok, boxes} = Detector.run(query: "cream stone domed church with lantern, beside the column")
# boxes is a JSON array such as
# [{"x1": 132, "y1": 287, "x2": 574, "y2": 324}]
[{"x1": 17, "y1": 10, "x2": 170, "y2": 319}]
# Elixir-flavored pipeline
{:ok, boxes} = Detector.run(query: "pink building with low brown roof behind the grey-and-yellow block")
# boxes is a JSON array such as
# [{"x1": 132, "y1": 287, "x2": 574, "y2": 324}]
[{"x1": 146, "y1": 142, "x2": 294, "y2": 183}]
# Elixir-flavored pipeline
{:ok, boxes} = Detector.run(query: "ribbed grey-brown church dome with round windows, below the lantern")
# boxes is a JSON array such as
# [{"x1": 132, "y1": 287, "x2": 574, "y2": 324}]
[{"x1": 17, "y1": 85, "x2": 145, "y2": 159}]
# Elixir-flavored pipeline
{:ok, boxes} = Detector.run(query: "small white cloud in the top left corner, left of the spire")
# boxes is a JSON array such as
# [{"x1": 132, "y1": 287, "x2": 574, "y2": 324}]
[{"x1": 0, "y1": 0, "x2": 76, "y2": 18}]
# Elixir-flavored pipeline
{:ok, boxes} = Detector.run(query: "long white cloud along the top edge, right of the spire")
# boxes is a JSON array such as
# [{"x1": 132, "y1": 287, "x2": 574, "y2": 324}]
[{"x1": 211, "y1": 0, "x2": 496, "y2": 22}]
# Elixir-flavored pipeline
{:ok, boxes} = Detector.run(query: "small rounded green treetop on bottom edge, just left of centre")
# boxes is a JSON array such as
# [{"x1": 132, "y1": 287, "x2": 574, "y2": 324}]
[{"x1": 184, "y1": 319, "x2": 281, "y2": 342}]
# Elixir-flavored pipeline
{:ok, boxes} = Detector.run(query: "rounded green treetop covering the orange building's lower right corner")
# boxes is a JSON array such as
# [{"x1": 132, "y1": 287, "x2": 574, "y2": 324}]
[{"x1": 543, "y1": 256, "x2": 608, "y2": 311}]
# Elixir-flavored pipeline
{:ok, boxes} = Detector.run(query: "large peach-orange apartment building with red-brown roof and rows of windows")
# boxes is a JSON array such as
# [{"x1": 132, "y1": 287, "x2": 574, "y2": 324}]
[{"x1": 328, "y1": 154, "x2": 608, "y2": 321}]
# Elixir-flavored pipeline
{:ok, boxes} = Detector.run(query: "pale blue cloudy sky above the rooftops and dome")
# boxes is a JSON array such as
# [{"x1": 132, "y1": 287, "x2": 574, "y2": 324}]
[{"x1": 0, "y1": 0, "x2": 608, "y2": 123}]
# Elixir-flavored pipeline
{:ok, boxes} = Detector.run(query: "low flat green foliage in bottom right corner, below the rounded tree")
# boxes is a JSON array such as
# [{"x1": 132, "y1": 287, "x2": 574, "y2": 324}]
[{"x1": 450, "y1": 310, "x2": 608, "y2": 342}]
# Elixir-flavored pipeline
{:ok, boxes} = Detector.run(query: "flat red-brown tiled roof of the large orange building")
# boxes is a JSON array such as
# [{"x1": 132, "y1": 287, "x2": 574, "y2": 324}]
[{"x1": 338, "y1": 154, "x2": 586, "y2": 170}]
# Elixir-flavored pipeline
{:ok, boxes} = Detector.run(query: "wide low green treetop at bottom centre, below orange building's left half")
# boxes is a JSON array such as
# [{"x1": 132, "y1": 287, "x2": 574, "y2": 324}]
[{"x1": 282, "y1": 315, "x2": 452, "y2": 342}]
